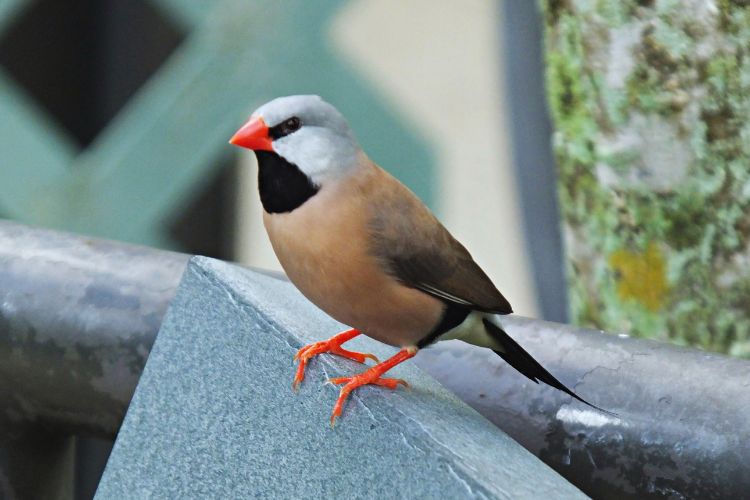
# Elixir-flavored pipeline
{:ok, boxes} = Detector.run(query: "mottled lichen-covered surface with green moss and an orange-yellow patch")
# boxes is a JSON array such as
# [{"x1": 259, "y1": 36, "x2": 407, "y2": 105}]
[{"x1": 542, "y1": 0, "x2": 750, "y2": 358}]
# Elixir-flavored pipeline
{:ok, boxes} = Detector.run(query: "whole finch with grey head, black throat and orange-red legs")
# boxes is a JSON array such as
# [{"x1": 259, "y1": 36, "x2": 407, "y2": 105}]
[{"x1": 229, "y1": 95, "x2": 600, "y2": 426}]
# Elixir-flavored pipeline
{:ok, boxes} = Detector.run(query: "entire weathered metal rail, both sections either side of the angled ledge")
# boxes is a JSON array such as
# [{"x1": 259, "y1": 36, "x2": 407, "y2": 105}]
[{"x1": 0, "y1": 221, "x2": 750, "y2": 498}]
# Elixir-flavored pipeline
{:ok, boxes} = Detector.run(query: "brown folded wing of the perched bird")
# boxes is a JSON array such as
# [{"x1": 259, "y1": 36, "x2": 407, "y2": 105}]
[{"x1": 370, "y1": 166, "x2": 513, "y2": 314}]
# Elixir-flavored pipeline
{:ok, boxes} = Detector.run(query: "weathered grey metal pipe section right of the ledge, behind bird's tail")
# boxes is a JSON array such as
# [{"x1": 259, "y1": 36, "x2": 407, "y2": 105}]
[{"x1": 415, "y1": 317, "x2": 750, "y2": 498}]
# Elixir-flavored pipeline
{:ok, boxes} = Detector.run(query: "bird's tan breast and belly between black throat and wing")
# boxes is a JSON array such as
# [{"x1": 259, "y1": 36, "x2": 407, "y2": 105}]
[{"x1": 263, "y1": 162, "x2": 443, "y2": 346}]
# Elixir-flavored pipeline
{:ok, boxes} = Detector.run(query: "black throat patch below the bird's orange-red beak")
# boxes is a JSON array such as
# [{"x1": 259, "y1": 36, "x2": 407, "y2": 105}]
[{"x1": 255, "y1": 151, "x2": 320, "y2": 214}]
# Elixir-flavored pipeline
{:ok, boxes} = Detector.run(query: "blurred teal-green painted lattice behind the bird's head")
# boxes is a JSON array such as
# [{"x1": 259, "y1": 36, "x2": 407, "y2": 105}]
[{"x1": 0, "y1": 0, "x2": 432, "y2": 248}]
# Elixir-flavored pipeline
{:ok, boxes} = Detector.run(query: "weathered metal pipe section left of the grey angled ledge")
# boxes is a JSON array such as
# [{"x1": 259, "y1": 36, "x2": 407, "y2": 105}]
[{"x1": 0, "y1": 221, "x2": 188, "y2": 438}]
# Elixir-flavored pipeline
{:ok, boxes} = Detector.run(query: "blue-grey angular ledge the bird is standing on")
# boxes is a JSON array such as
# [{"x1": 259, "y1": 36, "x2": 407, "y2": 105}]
[{"x1": 97, "y1": 257, "x2": 585, "y2": 499}]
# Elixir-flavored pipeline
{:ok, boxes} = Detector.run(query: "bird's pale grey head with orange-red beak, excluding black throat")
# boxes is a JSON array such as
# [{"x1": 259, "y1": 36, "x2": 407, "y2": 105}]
[{"x1": 229, "y1": 95, "x2": 359, "y2": 185}]
